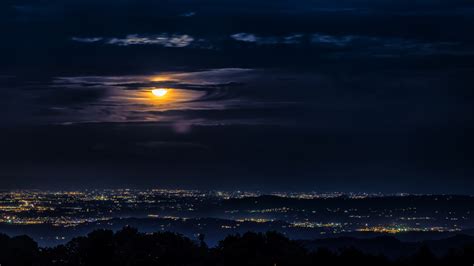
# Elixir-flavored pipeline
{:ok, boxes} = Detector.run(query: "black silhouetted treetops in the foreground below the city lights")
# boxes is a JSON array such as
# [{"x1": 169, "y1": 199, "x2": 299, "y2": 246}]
[{"x1": 0, "y1": 227, "x2": 474, "y2": 266}]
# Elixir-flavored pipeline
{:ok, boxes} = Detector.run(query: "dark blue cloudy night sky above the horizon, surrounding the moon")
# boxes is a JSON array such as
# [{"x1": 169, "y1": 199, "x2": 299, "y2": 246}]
[{"x1": 0, "y1": 0, "x2": 474, "y2": 194}]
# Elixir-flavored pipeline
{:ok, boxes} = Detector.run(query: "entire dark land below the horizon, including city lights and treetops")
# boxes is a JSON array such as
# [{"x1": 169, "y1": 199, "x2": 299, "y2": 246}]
[{"x1": 0, "y1": 189, "x2": 474, "y2": 265}]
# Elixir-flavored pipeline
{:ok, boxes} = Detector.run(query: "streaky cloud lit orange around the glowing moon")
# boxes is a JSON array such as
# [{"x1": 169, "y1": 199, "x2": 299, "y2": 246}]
[{"x1": 12, "y1": 68, "x2": 258, "y2": 126}]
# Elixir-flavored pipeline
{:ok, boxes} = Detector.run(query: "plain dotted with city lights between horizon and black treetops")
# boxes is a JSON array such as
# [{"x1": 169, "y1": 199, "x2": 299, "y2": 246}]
[{"x1": 0, "y1": 189, "x2": 471, "y2": 233}]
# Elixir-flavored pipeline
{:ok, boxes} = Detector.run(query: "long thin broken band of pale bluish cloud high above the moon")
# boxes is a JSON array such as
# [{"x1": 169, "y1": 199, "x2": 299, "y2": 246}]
[{"x1": 71, "y1": 29, "x2": 473, "y2": 57}]
